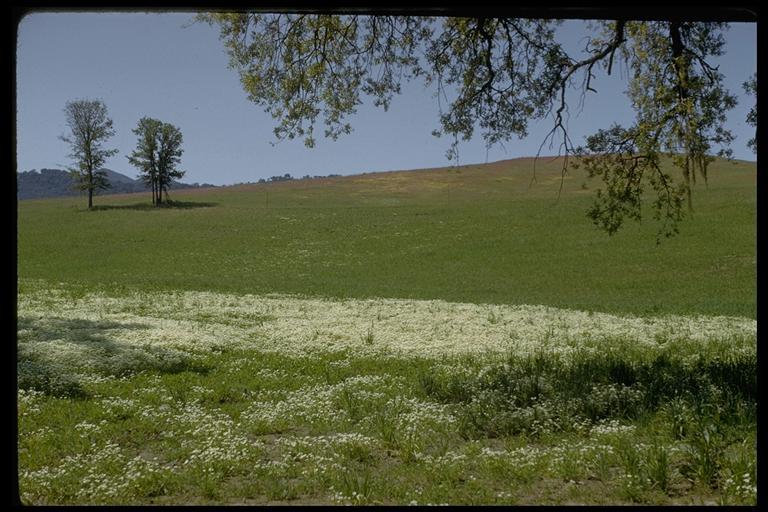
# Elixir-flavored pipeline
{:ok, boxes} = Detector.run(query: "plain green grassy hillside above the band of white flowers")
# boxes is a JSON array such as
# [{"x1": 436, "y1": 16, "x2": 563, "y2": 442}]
[{"x1": 18, "y1": 155, "x2": 756, "y2": 318}]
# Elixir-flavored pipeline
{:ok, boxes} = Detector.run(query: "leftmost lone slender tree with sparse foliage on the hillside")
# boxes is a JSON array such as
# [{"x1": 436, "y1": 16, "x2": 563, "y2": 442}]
[{"x1": 60, "y1": 100, "x2": 117, "y2": 209}]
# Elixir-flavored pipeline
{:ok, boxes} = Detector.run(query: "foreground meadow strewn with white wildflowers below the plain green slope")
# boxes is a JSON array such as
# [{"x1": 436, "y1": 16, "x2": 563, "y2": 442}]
[{"x1": 17, "y1": 278, "x2": 757, "y2": 505}]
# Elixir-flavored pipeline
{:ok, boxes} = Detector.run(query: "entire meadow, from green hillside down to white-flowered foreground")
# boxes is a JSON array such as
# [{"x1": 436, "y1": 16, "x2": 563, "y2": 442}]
[{"x1": 17, "y1": 156, "x2": 757, "y2": 505}]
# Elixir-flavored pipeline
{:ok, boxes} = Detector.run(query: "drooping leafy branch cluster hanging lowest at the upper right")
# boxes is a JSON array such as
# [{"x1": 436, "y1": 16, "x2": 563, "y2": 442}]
[{"x1": 577, "y1": 22, "x2": 735, "y2": 243}]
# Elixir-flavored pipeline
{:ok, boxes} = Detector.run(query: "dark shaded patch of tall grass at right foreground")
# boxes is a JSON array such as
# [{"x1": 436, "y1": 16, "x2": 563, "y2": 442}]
[{"x1": 420, "y1": 347, "x2": 757, "y2": 439}]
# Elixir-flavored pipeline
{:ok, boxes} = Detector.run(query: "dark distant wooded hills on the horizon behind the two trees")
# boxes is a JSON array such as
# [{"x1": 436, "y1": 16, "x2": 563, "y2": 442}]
[{"x1": 16, "y1": 169, "x2": 215, "y2": 200}]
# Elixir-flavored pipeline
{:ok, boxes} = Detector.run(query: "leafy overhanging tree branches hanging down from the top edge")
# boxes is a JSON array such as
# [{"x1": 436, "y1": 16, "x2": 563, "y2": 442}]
[{"x1": 198, "y1": 12, "x2": 756, "y2": 241}]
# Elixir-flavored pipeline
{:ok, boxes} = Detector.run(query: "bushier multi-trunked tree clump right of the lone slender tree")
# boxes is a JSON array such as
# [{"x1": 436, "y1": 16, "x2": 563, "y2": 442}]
[{"x1": 127, "y1": 117, "x2": 184, "y2": 206}]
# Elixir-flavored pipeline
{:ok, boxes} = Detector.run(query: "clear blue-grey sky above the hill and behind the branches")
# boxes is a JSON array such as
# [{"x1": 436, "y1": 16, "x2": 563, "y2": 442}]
[{"x1": 16, "y1": 12, "x2": 757, "y2": 185}]
